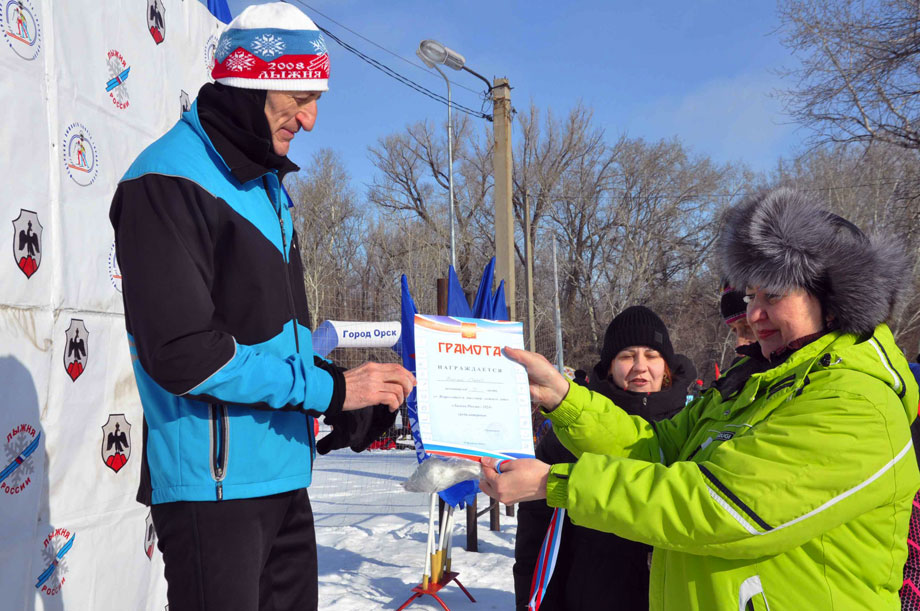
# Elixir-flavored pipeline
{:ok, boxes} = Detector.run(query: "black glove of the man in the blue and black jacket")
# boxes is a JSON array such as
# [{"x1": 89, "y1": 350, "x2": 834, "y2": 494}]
[{"x1": 314, "y1": 357, "x2": 396, "y2": 454}]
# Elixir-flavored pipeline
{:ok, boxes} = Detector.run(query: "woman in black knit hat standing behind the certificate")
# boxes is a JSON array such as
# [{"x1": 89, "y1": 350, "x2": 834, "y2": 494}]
[{"x1": 514, "y1": 306, "x2": 696, "y2": 611}]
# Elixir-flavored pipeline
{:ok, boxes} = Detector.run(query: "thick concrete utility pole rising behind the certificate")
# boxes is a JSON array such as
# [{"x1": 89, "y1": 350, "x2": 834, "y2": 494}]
[{"x1": 492, "y1": 78, "x2": 517, "y2": 320}]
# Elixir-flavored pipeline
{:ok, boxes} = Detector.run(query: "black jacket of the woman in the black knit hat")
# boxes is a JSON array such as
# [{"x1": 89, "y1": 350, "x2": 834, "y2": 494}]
[{"x1": 514, "y1": 355, "x2": 696, "y2": 611}]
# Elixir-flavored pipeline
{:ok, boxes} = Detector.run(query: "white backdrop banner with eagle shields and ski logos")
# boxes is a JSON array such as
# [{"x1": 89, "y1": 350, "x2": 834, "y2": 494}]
[{"x1": 0, "y1": 0, "x2": 223, "y2": 611}]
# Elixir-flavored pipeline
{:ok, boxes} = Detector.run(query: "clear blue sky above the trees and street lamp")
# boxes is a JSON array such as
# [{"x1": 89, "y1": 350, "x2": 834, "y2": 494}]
[{"x1": 221, "y1": 0, "x2": 807, "y2": 192}]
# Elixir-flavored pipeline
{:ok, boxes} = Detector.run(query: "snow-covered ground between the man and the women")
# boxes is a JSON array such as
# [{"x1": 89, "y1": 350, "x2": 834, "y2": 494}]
[{"x1": 310, "y1": 450, "x2": 517, "y2": 611}]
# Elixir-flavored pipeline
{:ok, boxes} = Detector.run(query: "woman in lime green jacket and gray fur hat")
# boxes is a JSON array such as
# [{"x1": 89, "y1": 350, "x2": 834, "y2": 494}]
[{"x1": 482, "y1": 189, "x2": 920, "y2": 611}]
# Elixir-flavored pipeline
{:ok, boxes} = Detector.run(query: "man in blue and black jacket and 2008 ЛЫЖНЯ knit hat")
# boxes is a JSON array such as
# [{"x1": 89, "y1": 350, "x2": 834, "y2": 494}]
[{"x1": 110, "y1": 2, "x2": 415, "y2": 611}]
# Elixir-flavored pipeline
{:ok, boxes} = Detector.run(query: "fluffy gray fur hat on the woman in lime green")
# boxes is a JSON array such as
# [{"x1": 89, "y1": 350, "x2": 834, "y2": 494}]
[{"x1": 719, "y1": 188, "x2": 910, "y2": 334}]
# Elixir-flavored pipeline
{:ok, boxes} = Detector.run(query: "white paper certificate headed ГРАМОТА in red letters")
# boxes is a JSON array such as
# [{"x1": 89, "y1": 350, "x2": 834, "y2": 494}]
[{"x1": 414, "y1": 314, "x2": 534, "y2": 460}]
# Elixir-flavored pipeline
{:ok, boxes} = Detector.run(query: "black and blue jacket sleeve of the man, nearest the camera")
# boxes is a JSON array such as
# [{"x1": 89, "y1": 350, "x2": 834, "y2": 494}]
[{"x1": 110, "y1": 174, "x2": 344, "y2": 415}]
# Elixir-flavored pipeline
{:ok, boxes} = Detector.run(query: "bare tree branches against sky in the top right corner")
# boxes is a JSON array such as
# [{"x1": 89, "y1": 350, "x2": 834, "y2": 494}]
[{"x1": 779, "y1": 0, "x2": 920, "y2": 149}]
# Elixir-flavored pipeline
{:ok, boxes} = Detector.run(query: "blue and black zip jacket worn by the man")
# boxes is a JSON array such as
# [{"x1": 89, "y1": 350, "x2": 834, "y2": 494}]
[{"x1": 110, "y1": 85, "x2": 378, "y2": 504}]
